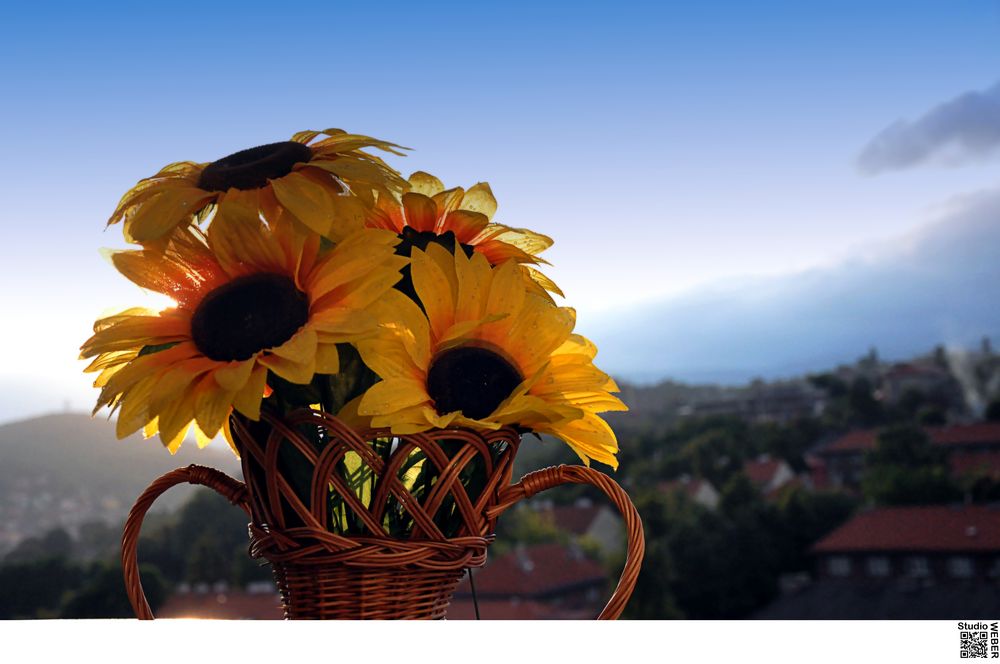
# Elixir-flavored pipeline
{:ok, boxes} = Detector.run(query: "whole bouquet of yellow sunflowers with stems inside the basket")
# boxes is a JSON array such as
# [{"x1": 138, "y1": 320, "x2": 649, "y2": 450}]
[{"x1": 81, "y1": 129, "x2": 625, "y2": 624}]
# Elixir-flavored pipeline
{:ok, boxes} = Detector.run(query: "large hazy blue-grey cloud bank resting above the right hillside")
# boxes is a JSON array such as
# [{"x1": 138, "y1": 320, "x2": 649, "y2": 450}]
[{"x1": 582, "y1": 189, "x2": 1000, "y2": 382}]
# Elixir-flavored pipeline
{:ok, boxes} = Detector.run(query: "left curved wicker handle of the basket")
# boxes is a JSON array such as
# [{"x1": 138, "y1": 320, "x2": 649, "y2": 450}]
[{"x1": 122, "y1": 464, "x2": 250, "y2": 620}]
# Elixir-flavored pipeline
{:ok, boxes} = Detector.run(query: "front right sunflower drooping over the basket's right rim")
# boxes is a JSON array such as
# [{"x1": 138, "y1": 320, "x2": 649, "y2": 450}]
[{"x1": 352, "y1": 244, "x2": 626, "y2": 467}]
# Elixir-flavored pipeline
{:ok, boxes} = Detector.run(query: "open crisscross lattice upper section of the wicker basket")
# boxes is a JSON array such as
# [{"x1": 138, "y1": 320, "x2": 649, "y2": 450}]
[{"x1": 233, "y1": 410, "x2": 520, "y2": 556}]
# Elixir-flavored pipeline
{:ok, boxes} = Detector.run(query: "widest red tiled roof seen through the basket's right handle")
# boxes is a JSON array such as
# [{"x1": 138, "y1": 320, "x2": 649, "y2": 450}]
[{"x1": 456, "y1": 544, "x2": 607, "y2": 598}]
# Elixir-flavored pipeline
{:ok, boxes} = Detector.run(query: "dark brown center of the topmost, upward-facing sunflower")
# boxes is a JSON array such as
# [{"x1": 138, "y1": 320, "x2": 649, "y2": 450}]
[{"x1": 198, "y1": 141, "x2": 312, "y2": 191}]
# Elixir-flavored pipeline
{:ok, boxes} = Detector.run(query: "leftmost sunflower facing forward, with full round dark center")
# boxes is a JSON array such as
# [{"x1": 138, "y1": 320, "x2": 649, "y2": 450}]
[{"x1": 81, "y1": 201, "x2": 406, "y2": 452}]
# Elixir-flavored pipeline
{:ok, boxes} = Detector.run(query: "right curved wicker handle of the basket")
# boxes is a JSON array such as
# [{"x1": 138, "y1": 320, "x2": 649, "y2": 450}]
[{"x1": 487, "y1": 465, "x2": 646, "y2": 620}]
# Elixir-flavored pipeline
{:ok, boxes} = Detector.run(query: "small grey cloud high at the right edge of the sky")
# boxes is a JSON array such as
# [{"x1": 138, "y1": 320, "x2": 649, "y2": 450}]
[{"x1": 858, "y1": 83, "x2": 1000, "y2": 174}]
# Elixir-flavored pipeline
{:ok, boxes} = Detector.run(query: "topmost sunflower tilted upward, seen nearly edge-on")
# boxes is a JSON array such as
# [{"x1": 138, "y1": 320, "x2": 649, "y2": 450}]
[{"x1": 108, "y1": 129, "x2": 405, "y2": 244}]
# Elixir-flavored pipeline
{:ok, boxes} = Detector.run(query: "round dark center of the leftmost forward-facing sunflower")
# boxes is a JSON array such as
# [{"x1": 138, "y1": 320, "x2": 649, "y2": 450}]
[{"x1": 191, "y1": 274, "x2": 309, "y2": 362}]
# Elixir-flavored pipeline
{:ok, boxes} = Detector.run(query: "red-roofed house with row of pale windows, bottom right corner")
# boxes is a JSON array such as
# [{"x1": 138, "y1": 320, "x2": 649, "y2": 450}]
[{"x1": 753, "y1": 505, "x2": 1000, "y2": 620}]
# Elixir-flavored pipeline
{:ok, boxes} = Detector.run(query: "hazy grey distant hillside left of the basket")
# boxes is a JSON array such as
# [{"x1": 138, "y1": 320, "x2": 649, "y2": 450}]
[{"x1": 0, "y1": 413, "x2": 241, "y2": 553}]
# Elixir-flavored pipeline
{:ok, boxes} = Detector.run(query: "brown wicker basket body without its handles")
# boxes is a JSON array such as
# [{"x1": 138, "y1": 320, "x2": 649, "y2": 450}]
[{"x1": 233, "y1": 410, "x2": 520, "y2": 618}]
